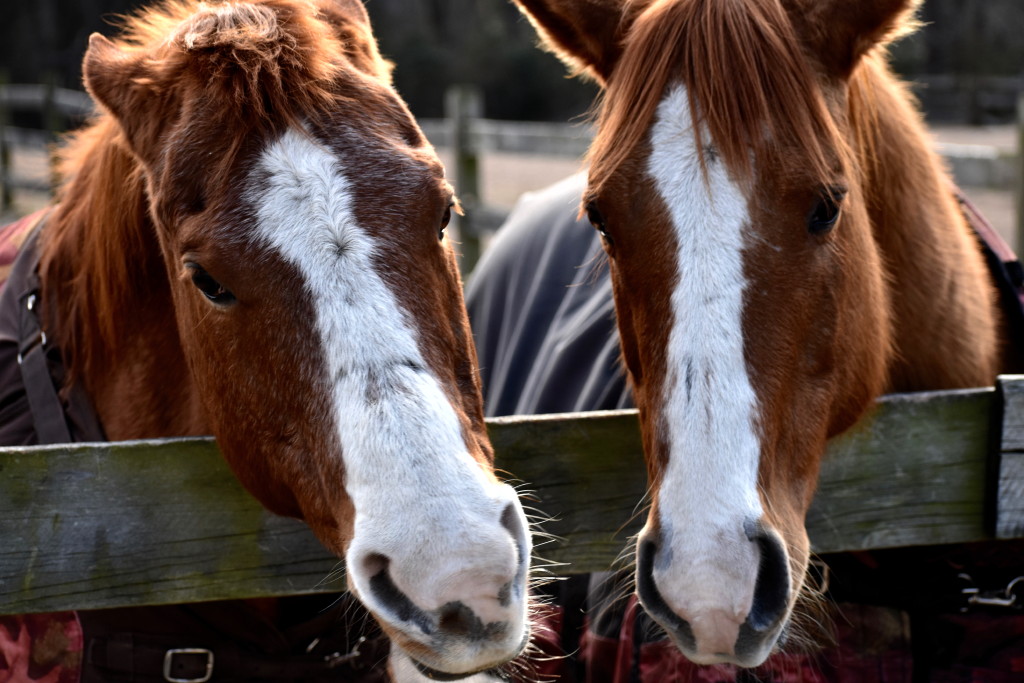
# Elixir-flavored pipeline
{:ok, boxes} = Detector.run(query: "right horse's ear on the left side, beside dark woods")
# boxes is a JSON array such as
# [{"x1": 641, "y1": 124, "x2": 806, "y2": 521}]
[{"x1": 515, "y1": 0, "x2": 643, "y2": 85}]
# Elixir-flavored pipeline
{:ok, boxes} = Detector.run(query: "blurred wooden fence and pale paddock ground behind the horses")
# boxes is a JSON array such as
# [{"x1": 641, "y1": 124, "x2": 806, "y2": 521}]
[{"x1": 0, "y1": 84, "x2": 1024, "y2": 270}]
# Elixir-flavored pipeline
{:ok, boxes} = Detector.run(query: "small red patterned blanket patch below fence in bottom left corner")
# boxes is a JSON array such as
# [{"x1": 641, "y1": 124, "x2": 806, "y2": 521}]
[{"x1": 0, "y1": 612, "x2": 83, "y2": 683}]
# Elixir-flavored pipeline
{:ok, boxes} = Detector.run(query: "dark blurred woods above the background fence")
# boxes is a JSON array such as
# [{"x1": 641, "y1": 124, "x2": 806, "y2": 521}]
[{"x1": 0, "y1": 0, "x2": 1024, "y2": 123}]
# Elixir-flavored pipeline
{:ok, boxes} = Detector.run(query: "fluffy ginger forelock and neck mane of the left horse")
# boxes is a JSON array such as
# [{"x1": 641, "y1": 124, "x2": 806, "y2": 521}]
[{"x1": 40, "y1": 0, "x2": 391, "y2": 383}]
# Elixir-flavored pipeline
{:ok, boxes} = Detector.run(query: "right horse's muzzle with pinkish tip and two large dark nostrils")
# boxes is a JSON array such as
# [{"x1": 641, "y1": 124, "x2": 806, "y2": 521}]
[{"x1": 636, "y1": 522, "x2": 791, "y2": 667}]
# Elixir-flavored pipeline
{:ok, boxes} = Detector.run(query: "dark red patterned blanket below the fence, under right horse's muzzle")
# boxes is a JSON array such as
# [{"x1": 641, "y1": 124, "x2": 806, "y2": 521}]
[{"x1": 579, "y1": 596, "x2": 1024, "y2": 683}]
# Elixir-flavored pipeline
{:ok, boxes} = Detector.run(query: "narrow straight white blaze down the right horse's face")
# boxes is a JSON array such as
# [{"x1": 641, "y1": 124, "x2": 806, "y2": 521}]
[{"x1": 648, "y1": 86, "x2": 762, "y2": 616}]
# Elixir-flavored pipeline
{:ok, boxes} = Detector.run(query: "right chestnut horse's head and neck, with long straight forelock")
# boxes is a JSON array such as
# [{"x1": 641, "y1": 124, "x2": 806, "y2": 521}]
[{"x1": 517, "y1": 0, "x2": 1004, "y2": 667}]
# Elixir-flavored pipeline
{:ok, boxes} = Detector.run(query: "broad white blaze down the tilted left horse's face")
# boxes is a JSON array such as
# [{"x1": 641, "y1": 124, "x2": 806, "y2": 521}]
[{"x1": 250, "y1": 131, "x2": 528, "y2": 655}]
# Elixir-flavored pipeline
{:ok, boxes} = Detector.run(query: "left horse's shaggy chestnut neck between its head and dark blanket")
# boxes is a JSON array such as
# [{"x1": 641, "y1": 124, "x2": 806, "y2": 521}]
[{"x1": 40, "y1": 121, "x2": 207, "y2": 440}]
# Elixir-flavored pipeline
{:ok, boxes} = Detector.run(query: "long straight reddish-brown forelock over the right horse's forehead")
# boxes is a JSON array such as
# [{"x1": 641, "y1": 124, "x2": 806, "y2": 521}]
[{"x1": 590, "y1": 0, "x2": 843, "y2": 193}]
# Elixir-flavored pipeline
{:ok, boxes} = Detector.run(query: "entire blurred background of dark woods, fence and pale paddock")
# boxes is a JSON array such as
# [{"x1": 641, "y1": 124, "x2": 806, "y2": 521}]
[{"x1": 0, "y1": 0, "x2": 1024, "y2": 270}]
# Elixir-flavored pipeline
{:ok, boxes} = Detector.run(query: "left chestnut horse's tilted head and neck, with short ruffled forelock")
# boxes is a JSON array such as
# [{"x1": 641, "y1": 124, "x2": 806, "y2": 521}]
[{"x1": 32, "y1": 0, "x2": 530, "y2": 675}]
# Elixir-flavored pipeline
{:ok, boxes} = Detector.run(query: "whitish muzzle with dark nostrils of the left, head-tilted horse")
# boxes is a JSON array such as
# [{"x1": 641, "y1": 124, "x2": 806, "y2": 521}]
[{"x1": 349, "y1": 496, "x2": 529, "y2": 676}]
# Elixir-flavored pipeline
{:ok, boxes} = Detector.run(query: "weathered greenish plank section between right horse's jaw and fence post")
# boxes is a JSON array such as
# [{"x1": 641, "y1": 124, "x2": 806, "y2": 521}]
[{"x1": 807, "y1": 389, "x2": 997, "y2": 553}]
